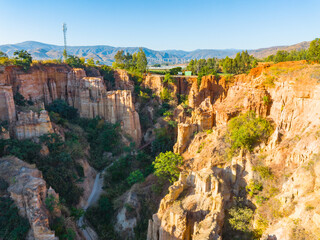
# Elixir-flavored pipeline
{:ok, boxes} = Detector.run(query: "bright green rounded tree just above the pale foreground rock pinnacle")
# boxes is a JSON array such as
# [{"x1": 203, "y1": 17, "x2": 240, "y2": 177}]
[{"x1": 152, "y1": 151, "x2": 183, "y2": 183}]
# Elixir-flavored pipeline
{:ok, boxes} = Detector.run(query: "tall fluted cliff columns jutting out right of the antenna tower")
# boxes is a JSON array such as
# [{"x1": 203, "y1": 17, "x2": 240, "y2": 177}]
[{"x1": 68, "y1": 70, "x2": 141, "y2": 146}]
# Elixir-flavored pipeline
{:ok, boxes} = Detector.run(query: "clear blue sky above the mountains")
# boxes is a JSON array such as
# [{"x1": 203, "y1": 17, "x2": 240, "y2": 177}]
[{"x1": 0, "y1": 0, "x2": 320, "y2": 50}]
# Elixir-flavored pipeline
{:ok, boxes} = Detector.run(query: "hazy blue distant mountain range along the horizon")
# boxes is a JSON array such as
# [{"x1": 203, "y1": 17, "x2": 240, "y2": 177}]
[{"x1": 0, "y1": 41, "x2": 310, "y2": 65}]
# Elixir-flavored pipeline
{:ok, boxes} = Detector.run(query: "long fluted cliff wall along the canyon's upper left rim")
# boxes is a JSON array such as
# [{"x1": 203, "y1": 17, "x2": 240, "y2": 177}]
[{"x1": 0, "y1": 64, "x2": 141, "y2": 146}]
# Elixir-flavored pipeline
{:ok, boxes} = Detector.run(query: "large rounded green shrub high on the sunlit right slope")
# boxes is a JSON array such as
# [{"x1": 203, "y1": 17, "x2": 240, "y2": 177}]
[{"x1": 227, "y1": 112, "x2": 272, "y2": 153}]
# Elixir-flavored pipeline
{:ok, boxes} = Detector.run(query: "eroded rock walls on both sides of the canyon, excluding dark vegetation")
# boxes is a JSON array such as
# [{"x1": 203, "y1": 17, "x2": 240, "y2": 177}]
[{"x1": 0, "y1": 61, "x2": 320, "y2": 240}]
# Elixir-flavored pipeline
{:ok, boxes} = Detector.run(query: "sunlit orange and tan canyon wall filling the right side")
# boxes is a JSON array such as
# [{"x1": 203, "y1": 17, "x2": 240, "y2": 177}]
[{"x1": 148, "y1": 62, "x2": 320, "y2": 240}]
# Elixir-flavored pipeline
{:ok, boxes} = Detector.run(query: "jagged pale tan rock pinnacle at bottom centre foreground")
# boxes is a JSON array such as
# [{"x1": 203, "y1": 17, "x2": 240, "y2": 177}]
[{"x1": 147, "y1": 169, "x2": 224, "y2": 240}]
